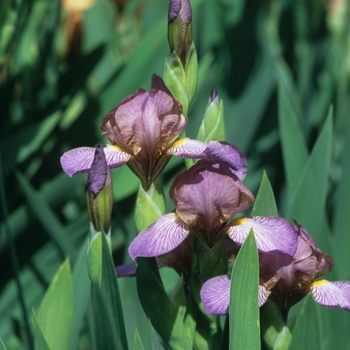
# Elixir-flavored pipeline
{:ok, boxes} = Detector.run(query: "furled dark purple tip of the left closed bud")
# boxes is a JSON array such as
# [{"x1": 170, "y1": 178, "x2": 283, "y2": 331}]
[{"x1": 86, "y1": 145, "x2": 109, "y2": 197}]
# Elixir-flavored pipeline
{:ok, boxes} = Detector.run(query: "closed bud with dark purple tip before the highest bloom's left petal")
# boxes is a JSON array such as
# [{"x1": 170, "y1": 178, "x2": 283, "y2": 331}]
[{"x1": 86, "y1": 145, "x2": 113, "y2": 234}]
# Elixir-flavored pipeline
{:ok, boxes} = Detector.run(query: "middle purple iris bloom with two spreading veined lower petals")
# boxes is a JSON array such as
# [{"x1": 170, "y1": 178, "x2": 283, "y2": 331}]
[{"x1": 129, "y1": 141, "x2": 296, "y2": 260}]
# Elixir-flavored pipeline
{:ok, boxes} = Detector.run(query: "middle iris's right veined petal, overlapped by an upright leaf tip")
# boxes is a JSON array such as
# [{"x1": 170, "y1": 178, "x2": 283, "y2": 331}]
[{"x1": 227, "y1": 216, "x2": 297, "y2": 256}]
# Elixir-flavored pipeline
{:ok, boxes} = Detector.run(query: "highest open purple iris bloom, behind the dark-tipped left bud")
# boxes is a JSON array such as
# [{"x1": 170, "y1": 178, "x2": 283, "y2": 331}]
[{"x1": 61, "y1": 75, "x2": 206, "y2": 190}]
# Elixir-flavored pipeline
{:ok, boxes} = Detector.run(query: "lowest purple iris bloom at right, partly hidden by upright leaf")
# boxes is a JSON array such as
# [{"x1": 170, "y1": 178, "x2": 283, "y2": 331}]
[{"x1": 200, "y1": 224, "x2": 350, "y2": 315}]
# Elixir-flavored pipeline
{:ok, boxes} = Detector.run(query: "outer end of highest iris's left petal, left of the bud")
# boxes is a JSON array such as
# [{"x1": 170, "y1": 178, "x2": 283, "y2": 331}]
[{"x1": 60, "y1": 147, "x2": 95, "y2": 177}]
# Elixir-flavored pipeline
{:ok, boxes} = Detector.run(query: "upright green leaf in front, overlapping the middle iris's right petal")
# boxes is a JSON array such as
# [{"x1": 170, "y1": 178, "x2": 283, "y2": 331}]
[{"x1": 229, "y1": 230, "x2": 260, "y2": 350}]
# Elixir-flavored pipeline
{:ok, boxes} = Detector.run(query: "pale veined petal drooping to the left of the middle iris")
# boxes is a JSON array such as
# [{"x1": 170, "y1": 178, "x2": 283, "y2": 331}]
[{"x1": 129, "y1": 213, "x2": 189, "y2": 260}]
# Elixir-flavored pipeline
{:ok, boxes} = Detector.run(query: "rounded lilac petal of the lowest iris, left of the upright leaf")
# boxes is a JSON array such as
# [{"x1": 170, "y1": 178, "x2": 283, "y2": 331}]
[{"x1": 200, "y1": 275, "x2": 231, "y2": 315}]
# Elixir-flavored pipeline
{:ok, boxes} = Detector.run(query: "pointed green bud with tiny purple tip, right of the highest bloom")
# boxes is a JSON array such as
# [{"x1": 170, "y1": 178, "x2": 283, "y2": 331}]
[{"x1": 197, "y1": 87, "x2": 225, "y2": 142}]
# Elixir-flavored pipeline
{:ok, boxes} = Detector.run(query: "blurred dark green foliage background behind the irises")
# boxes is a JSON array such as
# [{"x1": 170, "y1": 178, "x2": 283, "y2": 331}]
[{"x1": 0, "y1": 0, "x2": 350, "y2": 349}]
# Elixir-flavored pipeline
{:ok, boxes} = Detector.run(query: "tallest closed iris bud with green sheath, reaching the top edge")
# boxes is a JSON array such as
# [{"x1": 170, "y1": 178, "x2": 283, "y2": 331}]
[{"x1": 164, "y1": 0, "x2": 198, "y2": 115}]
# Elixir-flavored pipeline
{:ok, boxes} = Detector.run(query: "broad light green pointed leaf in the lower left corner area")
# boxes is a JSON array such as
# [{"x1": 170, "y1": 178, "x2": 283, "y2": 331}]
[{"x1": 38, "y1": 259, "x2": 73, "y2": 350}]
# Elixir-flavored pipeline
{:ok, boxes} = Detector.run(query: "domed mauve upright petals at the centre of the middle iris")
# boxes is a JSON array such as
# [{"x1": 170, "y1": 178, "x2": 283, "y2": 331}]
[{"x1": 170, "y1": 160, "x2": 254, "y2": 235}]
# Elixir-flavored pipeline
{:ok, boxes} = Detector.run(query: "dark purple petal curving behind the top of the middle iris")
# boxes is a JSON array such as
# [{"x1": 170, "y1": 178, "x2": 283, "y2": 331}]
[{"x1": 205, "y1": 141, "x2": 247, "y2": 181}]
